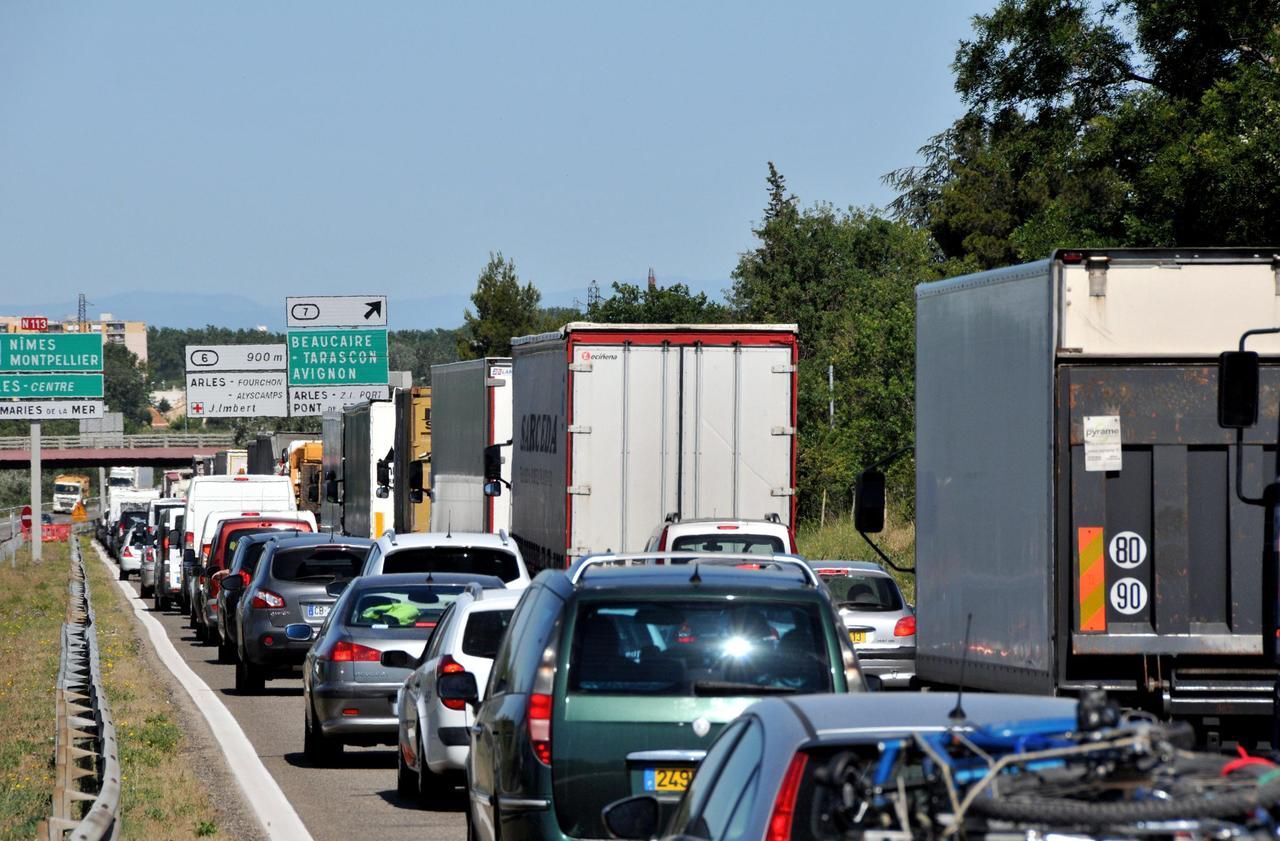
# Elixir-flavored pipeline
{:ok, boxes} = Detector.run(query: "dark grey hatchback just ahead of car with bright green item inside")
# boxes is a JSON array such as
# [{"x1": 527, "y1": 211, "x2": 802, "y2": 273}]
[{"x1": 223, "y1": 534, "x2": 372, "y2": 693}]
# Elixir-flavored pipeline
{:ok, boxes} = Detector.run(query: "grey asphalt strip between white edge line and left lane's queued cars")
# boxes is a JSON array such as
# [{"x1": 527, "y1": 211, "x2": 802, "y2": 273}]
[{"x1": 116, "y1": 558, "x2": 467, "y2": 841}]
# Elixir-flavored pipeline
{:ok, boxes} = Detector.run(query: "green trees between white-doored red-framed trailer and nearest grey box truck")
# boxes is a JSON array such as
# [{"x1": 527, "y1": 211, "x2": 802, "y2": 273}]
[{"x1": 732, "y1": 164, "x2": 938, "y2": 518}]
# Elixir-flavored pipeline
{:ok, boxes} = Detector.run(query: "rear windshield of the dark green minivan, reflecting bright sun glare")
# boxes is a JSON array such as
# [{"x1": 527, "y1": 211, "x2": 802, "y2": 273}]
[{"x1": 568, "y1": 597, "x2": 832, "y2": 696}]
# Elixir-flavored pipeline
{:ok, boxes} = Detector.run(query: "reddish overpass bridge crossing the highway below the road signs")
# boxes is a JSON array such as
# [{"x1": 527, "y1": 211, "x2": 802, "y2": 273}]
[{"x1": 0, "y1": 433, "x2": 236, "y2": 470}]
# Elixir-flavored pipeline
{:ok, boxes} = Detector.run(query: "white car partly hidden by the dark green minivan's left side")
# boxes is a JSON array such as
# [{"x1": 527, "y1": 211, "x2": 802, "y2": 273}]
[{"x1": 396, "y1": 590, "x2": 524, "y2": 805}]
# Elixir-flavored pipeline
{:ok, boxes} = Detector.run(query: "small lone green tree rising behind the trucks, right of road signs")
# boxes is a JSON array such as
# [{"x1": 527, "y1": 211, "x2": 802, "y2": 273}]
[{"x1": 457, "y1": 251, "x2": 545, "y2": 360}]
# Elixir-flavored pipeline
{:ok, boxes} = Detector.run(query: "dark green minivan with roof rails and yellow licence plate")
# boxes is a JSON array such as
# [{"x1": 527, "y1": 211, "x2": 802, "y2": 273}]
[{"x1": 448, "y1": 553, "x2": 867, "y2": 841}]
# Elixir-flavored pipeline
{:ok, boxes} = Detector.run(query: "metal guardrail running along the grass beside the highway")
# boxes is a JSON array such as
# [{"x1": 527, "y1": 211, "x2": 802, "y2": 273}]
[{"x1": 41, "y1": 536, "x2": 120, "y2": 841}]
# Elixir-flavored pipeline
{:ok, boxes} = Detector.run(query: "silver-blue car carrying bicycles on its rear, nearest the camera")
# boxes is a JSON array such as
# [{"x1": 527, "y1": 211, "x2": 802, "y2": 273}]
[{"x1": 604, "y1": 693, "x2": 1078, "y2": 841}]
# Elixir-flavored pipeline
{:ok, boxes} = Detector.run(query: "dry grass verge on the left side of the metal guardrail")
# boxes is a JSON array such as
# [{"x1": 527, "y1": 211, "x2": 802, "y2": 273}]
[{"x1": 0, "y1": 543, "x2": 70, "y2": 841}]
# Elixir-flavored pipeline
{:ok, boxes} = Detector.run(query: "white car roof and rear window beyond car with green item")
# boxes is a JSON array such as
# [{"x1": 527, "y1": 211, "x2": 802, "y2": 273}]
[{"x1": 360, "y1": 529, "x2": 531, "y2": 590}]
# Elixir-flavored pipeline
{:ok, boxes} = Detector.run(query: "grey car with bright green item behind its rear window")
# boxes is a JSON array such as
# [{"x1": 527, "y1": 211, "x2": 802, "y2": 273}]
[{"x1": 302, "y1": 572, "x2": 502, "y2": 762}]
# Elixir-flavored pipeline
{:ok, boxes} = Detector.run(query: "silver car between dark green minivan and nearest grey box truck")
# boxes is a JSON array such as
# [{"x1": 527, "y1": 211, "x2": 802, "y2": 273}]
[{"x1": 809, "y1": 561, "x2": 915, "y2": 687}]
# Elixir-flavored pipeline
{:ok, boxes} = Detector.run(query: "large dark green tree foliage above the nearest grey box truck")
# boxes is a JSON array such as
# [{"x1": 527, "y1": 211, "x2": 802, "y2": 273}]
[{"x1": 886, "y1": 0, "x2": 1280, "y2": 267}]
